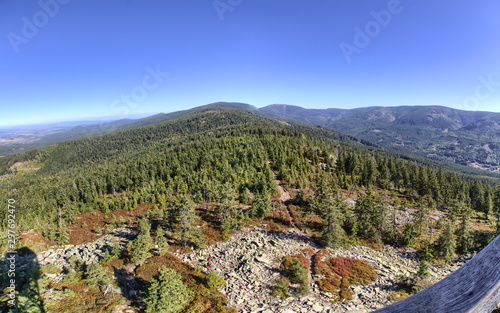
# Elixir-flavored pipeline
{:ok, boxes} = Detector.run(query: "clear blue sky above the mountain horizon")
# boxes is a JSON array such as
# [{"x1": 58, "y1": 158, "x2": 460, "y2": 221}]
[{"x1": 0, "y1": 0, "x2": 500, "y2": 127}]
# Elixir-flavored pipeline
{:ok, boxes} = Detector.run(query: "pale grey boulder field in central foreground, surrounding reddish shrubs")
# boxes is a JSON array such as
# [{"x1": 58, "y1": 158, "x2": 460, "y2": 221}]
[{"x1": 177, "y1": 228, "x2": 467, "y2": 313}]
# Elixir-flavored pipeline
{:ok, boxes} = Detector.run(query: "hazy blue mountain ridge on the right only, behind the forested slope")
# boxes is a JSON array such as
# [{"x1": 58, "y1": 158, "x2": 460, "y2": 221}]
[{"x1": 259, "y1": 104, "x2": 500, "y2": 172}]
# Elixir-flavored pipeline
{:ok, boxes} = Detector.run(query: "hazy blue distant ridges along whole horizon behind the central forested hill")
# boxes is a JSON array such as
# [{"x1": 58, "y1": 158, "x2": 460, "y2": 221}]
[{"x1": 0, "y1": 102, "x2": 500, "y2": 173}]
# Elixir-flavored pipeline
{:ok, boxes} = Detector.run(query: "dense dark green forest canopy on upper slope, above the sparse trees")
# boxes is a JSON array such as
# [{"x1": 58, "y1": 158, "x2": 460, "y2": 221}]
[{"x1": 0, "y1": 108, "x2": 498, "y2": 235}]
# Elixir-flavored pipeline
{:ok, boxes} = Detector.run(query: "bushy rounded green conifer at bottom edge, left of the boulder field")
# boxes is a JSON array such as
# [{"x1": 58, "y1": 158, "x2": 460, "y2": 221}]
[{"x1": 144, "y1": 266, "x2": 192, "y2": 313}]
